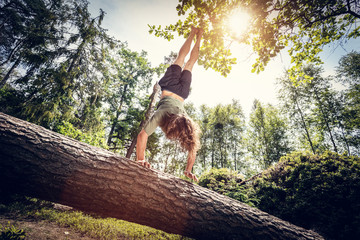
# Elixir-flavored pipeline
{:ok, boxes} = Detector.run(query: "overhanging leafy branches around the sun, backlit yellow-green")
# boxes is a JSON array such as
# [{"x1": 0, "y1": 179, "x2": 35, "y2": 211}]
[{"x1": 149, "y1": 0, "x2": 360, "y2": 79}]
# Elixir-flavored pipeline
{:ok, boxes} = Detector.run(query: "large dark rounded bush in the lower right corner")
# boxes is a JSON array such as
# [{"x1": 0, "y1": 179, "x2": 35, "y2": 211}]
[{"x1": 253, "y1": 152, "x2": 360, "y2": 239}]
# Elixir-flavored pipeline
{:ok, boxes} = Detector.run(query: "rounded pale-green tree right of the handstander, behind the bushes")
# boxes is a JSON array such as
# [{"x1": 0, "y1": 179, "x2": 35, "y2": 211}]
[{"x1": 246, "y1": 100, "x2": 290, "y2": 168}]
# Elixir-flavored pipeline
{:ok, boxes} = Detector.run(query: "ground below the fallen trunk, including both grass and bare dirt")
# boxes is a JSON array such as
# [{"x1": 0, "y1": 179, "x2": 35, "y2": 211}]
[{"x1": 0, "y1": 197, "x2": 191, "y2": 240}]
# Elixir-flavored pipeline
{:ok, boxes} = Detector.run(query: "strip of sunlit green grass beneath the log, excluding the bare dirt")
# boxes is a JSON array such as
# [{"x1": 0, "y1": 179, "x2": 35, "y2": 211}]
[{"x1": 0, "y1": 197, "x2": 193, "y2": 240}]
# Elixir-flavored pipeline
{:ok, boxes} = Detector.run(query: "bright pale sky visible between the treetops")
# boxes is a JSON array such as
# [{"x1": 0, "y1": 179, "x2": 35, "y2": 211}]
[{"x1": 89, "y1": 0, "x2": 360, "y2": 117}]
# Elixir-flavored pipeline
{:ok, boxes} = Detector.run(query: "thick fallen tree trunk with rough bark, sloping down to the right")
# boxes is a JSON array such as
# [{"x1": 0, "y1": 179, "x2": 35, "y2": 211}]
[{"x1": 0, "y1": 113, "x2": 323, "y2": 240}]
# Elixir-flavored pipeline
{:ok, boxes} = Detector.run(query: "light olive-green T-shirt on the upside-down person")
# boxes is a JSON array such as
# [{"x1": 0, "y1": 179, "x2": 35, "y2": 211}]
[{"x1": 144, "y1": 96, "x2": 187, "y2": 136}]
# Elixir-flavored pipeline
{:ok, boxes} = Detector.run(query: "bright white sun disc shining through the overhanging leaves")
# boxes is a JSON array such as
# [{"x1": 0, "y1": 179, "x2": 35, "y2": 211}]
[{"x1": 225, "y1": 8, "x2": 250, "y2": 37}]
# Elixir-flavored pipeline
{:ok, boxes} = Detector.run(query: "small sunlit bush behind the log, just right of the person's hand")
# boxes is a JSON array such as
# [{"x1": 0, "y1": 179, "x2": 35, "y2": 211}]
[{"x1": 199, "y1": 168, "x2": 258, "y2": 207}]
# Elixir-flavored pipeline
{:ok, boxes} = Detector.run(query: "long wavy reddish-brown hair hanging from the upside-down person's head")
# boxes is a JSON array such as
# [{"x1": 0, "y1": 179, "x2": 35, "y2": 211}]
[{"x1": 160, "y1": 114, "x2": 200, "y2": 152}]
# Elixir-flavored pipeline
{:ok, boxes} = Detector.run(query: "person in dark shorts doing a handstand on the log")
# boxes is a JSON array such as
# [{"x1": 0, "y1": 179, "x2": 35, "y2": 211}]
[{"x1": 136, "y1": 27, "x2": 203, "y2": 181}]
